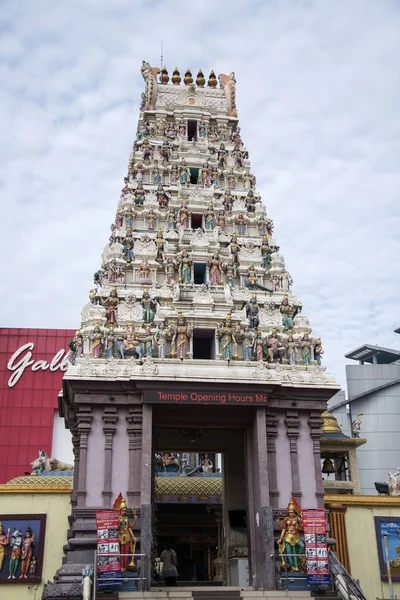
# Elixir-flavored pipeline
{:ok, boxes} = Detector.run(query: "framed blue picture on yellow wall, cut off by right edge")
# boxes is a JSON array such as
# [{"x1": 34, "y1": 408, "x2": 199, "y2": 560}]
[{"x1": 374, "y1": 517, "x2": 400, "y2": 581}]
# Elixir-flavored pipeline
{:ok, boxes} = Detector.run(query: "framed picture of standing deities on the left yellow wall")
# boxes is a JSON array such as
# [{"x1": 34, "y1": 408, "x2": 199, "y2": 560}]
[{"x1": 0, "y1": 514, "x2": 46, "y2": 585}]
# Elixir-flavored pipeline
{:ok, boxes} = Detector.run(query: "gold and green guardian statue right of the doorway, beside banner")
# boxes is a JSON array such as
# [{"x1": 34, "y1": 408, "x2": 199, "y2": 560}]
[{"x1": 277, "y1": 498, "x2": 304, "y2": 572}]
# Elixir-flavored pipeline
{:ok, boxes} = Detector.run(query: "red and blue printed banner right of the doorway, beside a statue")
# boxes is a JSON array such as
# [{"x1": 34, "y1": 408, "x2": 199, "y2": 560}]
[{"x1": 302, "y1": 509, "x2": 331, "y2": 585}]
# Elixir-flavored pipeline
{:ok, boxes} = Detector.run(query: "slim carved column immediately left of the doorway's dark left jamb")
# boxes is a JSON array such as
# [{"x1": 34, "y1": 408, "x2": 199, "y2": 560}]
[{"x1": 126, "y1": 404, "x2": 143, "y2": 506}]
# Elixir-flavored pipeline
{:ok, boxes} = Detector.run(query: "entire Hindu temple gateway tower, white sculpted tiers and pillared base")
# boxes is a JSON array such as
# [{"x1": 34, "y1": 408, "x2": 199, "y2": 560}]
[{"x1": 44, "y1": 62, "x2": 339, "y2": 599}]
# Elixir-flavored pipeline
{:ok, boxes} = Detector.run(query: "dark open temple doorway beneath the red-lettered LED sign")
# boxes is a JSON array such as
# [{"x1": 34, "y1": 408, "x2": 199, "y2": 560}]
[{"x1": 152, "y1": 407, "x2": 248, "y2": 586}]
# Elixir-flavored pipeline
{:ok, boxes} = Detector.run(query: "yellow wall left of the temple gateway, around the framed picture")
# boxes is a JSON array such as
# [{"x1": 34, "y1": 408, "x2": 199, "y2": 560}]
[{"x1": 0, "y1": 492, "x2": 71, "y2": 600}]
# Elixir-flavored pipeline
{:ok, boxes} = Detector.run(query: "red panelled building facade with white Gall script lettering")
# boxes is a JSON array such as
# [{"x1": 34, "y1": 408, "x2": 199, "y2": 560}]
[{"x1": 0, "y1": 328, "x2": 75, "y2": 483}]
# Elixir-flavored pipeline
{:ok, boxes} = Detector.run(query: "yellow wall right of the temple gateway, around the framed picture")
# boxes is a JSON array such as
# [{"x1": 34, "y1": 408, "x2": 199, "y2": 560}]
[{"x1": 345, "y1": 506, "x2": 400, "y2": 600}]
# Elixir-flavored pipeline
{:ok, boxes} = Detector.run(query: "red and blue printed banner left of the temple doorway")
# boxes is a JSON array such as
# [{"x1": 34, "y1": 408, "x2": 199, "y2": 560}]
[{"x1": 96, "y1": 510, "x2": 122, "y2": 588}]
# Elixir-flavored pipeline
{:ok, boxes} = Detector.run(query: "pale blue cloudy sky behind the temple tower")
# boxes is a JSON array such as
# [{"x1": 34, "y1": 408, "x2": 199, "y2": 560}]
[{"x1": 0, "y1": 0, "x2": 400, "y2": 384}]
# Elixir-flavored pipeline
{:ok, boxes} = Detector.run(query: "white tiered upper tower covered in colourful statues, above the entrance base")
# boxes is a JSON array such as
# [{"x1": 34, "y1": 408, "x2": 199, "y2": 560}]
[{"x1": 69, "y1": 62, "x2": 324, "y2": 370}]
